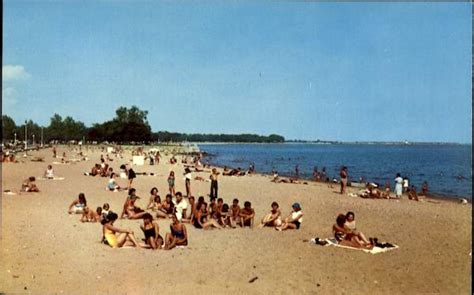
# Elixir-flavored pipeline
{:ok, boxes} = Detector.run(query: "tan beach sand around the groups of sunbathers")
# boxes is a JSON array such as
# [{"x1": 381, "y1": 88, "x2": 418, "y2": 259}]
[{"x1": 0, "y1": 146, "x2": 472, "y2": 294}]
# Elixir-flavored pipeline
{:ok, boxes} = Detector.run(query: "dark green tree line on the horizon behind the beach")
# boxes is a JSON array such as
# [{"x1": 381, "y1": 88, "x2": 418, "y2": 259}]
[{"x1": 2, "y1": 106, "x2": 285, "y2": 143}]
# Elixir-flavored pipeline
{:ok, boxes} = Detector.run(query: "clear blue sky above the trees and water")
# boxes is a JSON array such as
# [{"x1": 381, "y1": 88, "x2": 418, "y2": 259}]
[{"x1": 2, "y1": 0, "x2": 472, "y2": 143}]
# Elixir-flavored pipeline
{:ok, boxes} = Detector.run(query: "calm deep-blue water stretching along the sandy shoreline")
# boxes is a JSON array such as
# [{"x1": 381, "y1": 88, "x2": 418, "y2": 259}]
[{"x1": 199, "y1": 144, "x2": 472, "y2": 199}]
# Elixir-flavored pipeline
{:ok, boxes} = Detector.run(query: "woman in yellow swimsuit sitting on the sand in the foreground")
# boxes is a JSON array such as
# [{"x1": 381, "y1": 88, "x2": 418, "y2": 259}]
[{"x1": 102, "y1": 212, "x2": 147, "y2": 248}]
